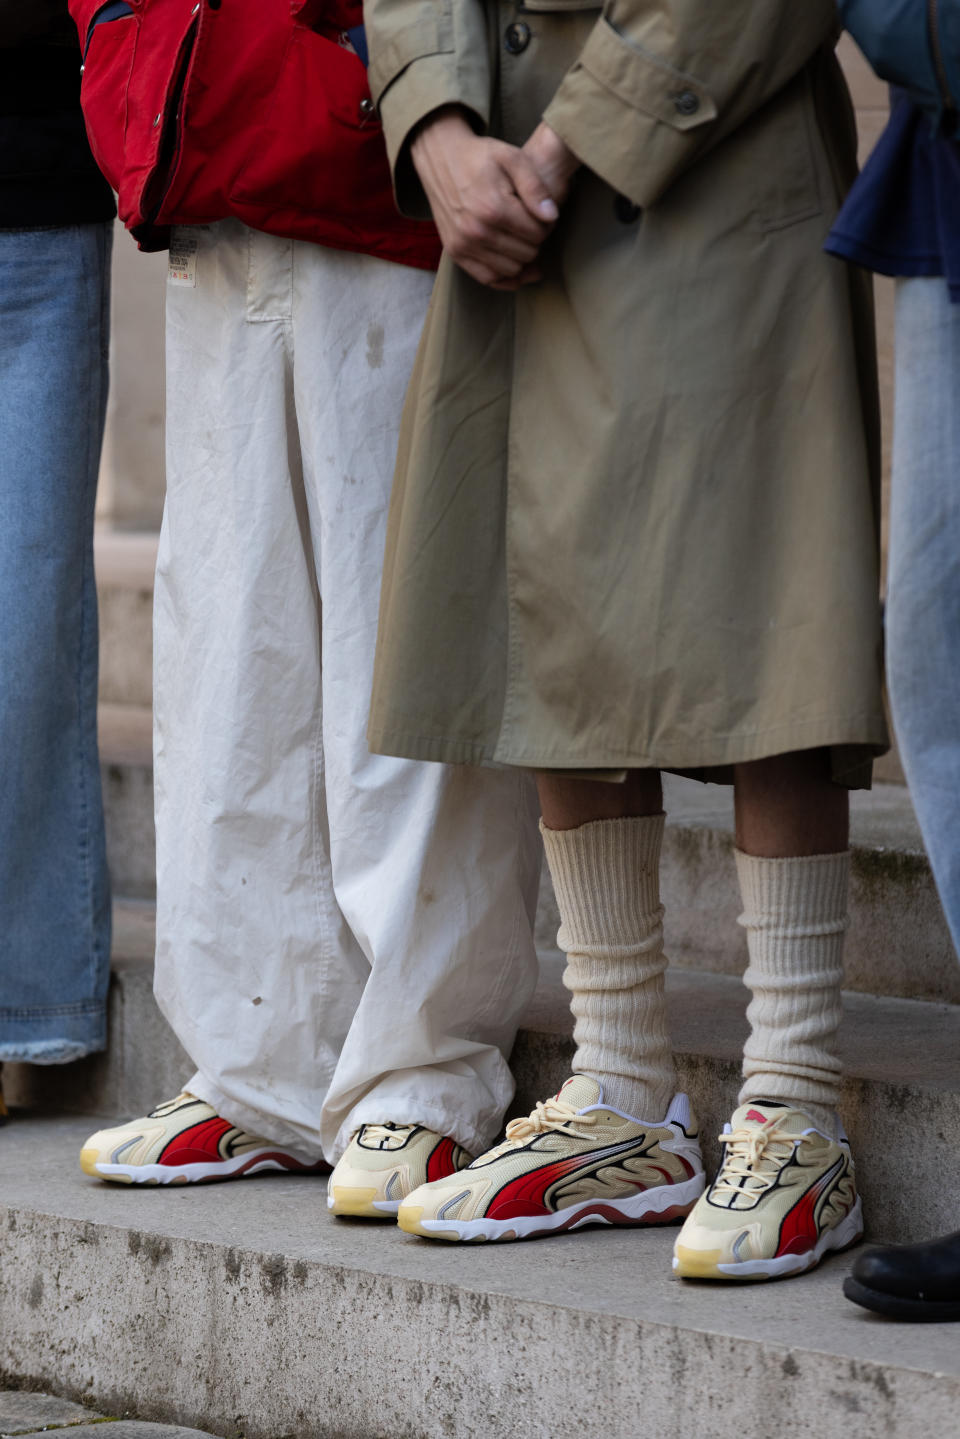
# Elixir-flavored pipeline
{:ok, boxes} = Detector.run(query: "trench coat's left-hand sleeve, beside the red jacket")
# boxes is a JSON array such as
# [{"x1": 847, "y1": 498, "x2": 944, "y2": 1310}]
[{"x1": 364, "y1": 0, "x2": 492, "y2": 219}]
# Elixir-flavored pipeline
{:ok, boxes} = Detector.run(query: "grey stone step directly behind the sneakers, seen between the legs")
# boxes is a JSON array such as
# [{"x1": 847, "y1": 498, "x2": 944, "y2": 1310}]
[{"x1": 4, "y1": 901, "x2": 960, "y2": 1240}]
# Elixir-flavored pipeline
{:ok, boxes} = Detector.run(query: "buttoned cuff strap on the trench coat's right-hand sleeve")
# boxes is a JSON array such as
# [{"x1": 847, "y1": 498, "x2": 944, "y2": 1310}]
[{"x1": 580, "y1": 20, "x2": 717, "y2": 130}]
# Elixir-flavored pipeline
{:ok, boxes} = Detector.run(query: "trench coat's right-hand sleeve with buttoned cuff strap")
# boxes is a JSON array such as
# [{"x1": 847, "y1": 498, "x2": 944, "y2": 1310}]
[{"x1": 544, "y1": 0, "x2": 838, "y2": 206}]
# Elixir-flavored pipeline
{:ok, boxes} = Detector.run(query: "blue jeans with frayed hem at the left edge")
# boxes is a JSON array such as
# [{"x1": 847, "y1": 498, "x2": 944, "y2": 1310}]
[{"x1": 0, "y1": 224, "x2": 112, "y2": 1063}]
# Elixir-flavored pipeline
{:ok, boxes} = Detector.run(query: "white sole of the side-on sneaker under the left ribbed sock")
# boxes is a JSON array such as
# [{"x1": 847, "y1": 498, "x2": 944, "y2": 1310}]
[{"x1": 397, "y1": 1171, "x2": 705, "y2": 1243}]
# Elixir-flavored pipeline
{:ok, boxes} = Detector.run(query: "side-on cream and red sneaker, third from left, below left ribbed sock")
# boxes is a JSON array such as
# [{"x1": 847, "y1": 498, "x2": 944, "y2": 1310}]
[{"x1": 397, "y1": 1075, "x2": 704, "y2": 1240}]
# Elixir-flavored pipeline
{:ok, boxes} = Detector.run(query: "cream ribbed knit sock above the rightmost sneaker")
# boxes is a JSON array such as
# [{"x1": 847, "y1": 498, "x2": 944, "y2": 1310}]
[{"x1": 737, "y1": 850, "x2": 851, "y2": 1132}]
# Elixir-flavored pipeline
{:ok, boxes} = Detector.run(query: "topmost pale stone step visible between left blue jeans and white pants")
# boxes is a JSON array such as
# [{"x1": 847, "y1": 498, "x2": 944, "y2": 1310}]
[{"x1": 94, "y1": 528, "x2": 158, "y2": 705}]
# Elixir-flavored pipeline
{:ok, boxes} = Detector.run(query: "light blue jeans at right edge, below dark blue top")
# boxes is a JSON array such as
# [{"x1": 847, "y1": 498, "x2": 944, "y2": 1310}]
[{"x1": 887, "y1": 279, "x2": 960, "y2": 953}]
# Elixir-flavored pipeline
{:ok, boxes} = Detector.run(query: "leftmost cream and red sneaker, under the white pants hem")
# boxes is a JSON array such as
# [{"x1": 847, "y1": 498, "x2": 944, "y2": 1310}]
[{"x1": 81, "y1": 1094, "x2": 330, "y2": 1184}]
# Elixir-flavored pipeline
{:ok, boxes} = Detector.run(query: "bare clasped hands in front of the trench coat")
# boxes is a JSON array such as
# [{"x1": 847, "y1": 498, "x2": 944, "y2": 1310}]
[{"x1": 410, "y1": 106, "x2": 580, "y2": 291}]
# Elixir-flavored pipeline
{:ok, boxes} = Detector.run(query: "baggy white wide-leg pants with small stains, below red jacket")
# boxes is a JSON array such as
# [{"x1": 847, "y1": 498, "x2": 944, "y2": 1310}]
[{"x1": 154, "y1": 222, "x2": 540, "y2": 1163}]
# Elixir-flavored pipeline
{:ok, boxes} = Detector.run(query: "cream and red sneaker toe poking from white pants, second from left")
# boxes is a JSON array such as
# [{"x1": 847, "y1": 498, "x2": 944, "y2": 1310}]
[{"x1": 327, "y1": 1124, "x2": 471, "y2": 1219}]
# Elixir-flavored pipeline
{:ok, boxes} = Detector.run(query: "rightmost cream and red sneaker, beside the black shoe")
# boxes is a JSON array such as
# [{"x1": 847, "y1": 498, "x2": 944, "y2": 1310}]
[{"x1": 674, "y1": 1099, "x2": 864, "y2": 1279}]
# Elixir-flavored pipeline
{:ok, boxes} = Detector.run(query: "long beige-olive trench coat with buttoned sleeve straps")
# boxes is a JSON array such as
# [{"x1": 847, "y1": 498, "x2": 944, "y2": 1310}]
[{"x1": 366, "y1": 0, "x2": 887, "y2": 784}]
